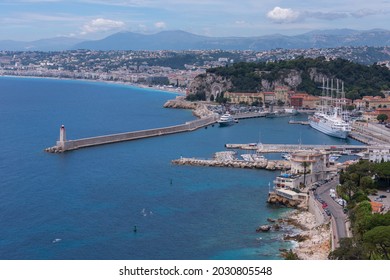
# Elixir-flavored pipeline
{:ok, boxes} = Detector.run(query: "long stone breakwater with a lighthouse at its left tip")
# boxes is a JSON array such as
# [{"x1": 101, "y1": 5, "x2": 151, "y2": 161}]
[{"x1": 45, "y1": 115, "x2": 218, "y2": 153}]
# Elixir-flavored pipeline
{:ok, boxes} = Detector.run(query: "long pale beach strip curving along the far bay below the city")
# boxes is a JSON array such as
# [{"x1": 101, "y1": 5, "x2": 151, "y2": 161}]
[{"x1": 0, "y1": 74, "x2": 186, "y2": 96}]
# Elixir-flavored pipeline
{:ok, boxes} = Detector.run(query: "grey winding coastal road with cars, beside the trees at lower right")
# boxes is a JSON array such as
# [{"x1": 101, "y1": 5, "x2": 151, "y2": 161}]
[{"x1": 316, "y1": 177, "x2": 348, "y2": 239}]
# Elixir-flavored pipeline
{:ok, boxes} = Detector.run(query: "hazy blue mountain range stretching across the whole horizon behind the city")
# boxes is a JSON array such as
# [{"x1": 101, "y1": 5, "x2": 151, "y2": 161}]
[{"x1": 0, "y1": 29, "x2": 390, "y2": 51}]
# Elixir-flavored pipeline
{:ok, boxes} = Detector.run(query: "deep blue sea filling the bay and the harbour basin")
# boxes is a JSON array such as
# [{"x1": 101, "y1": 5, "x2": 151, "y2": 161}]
[{"x1": 0, "y1": 77, "x2": 358, "y2": 260}]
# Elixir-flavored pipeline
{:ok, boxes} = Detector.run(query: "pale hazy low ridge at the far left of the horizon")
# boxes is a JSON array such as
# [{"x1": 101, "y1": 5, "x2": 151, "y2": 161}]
[{"x1": 0, "y1": 37, "x2": 83, "y2": 51}]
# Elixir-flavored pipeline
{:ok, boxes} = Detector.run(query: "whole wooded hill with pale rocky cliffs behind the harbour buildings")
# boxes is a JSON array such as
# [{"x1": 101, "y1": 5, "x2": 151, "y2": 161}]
[{"x1": 190, "y1": 57, "x2": 390, "y2": 99}]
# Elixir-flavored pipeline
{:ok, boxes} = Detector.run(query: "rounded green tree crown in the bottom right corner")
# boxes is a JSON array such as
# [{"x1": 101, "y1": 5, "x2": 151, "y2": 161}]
[{"x1": 363, "y1": 226, "x2": 390, "y2": 260}]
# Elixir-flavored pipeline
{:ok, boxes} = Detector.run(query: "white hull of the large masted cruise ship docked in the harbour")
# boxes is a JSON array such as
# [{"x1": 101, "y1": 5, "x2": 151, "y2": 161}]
[{"x1": 309, "y1": 108, "x2": 351, "y2": 139}]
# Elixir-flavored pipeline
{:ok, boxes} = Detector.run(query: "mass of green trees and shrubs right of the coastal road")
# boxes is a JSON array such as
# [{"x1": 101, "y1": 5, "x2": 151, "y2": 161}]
[{"x1": 329, "y1": 160, "x2": 390, "y2": 260}]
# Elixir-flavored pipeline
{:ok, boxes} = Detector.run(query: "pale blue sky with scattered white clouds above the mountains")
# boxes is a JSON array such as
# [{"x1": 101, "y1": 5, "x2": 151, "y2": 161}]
[{"x1": 0, "y1": 0, "x2": 390, "y2": 41}]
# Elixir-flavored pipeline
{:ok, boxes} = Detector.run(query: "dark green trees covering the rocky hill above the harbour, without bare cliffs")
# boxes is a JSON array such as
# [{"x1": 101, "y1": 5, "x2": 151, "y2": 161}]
[{"x1": 207, "y1": 57, "x2": 390, "y2": 99}]
